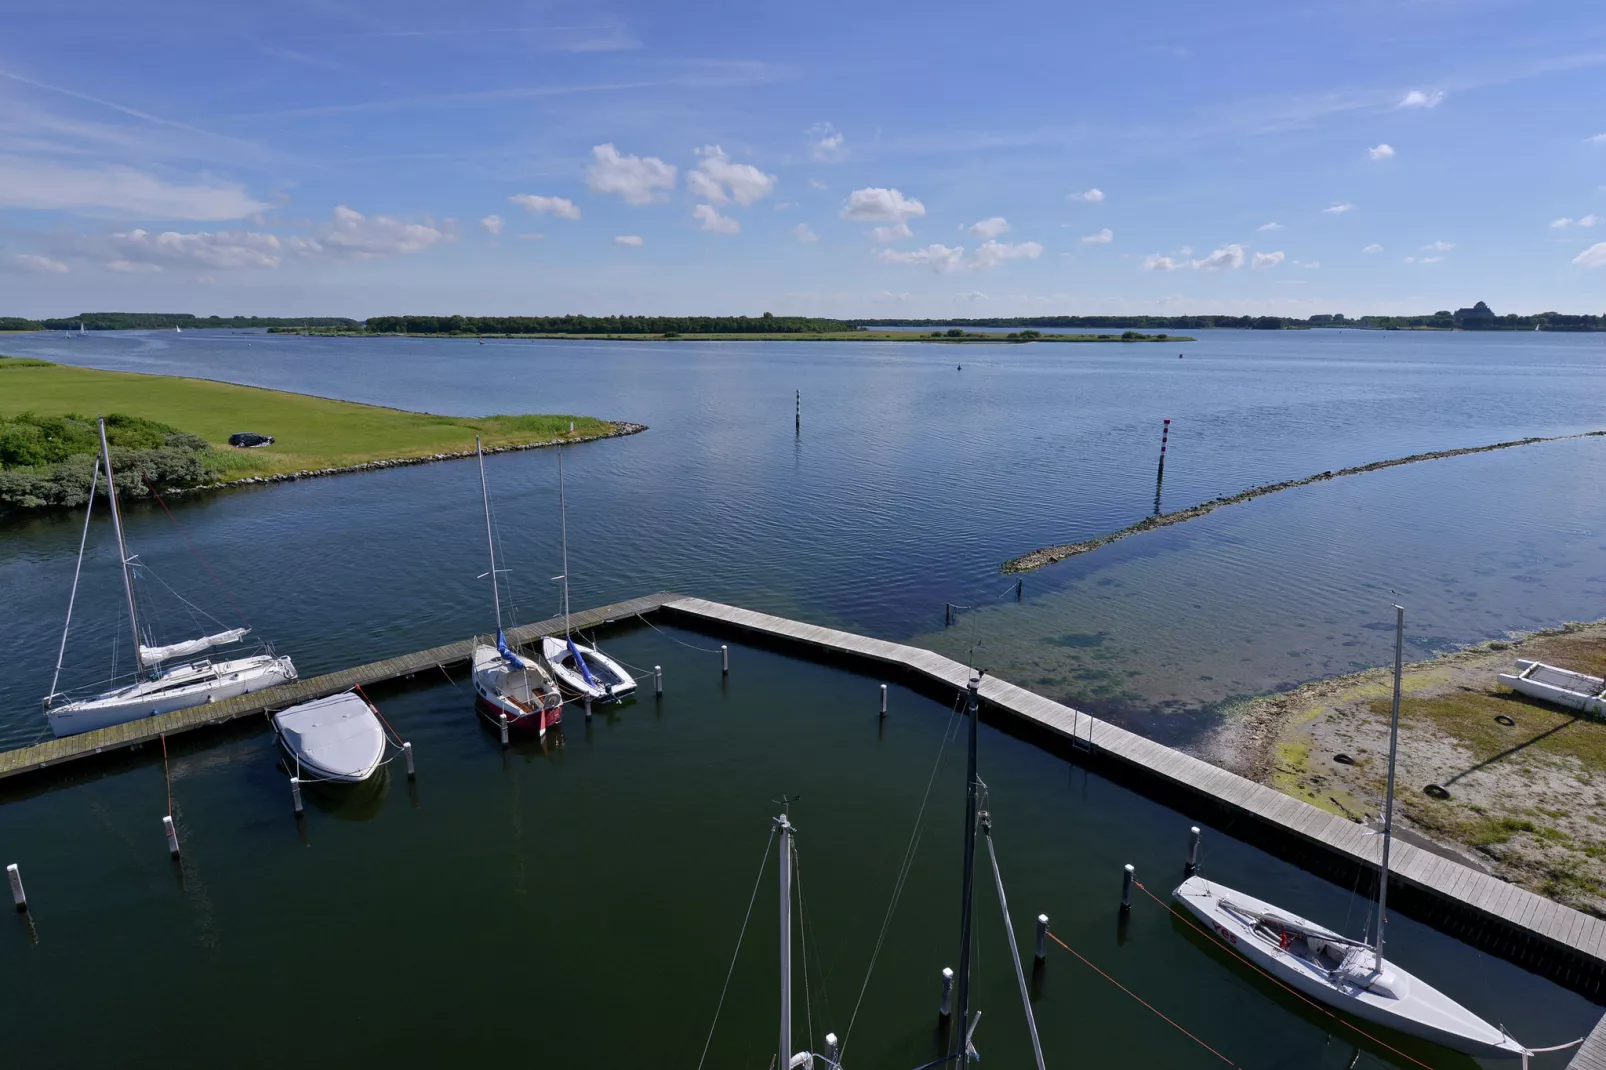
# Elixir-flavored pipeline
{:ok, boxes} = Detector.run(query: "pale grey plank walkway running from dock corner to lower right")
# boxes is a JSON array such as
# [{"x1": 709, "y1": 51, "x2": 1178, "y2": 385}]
[{"x1": 663, "y1": 598, "x2": 1606, "y2": 989}]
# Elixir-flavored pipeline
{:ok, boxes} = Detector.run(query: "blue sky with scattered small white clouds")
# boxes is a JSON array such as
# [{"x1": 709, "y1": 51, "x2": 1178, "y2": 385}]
[{"x1": 0, "y1": 0, "x2": 1606, "y2": 317}]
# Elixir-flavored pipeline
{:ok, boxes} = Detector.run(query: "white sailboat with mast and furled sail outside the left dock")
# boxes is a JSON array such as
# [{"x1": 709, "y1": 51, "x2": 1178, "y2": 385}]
[{"x1": 45, "y1": 416, "x2": 296, "y2": 737}]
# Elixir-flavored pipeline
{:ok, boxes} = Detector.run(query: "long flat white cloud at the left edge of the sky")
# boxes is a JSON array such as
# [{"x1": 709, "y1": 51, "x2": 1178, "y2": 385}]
[{"x1": 0, "y1": 156, "x2": 268, "y2": 220}]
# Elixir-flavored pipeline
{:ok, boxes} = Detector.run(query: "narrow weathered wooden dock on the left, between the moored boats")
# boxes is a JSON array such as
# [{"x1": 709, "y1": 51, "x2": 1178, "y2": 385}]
[{"x1": 0, "y1": 593, "x2": 675, "y2": 778}]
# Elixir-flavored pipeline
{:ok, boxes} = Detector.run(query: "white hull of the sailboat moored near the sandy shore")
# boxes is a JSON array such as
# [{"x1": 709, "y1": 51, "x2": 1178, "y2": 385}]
[{"x1": 1172, "y1": 877, "x2": 1524, "y2": 1059}]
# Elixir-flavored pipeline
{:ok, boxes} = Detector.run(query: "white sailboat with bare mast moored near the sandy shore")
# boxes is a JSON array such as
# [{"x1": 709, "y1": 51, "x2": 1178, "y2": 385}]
[{"x1": 1172, "y1": 606, "x2": 1532, "y2": 1059}]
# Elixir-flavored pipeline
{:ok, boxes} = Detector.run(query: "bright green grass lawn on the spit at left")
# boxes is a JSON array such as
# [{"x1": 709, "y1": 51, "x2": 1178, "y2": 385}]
[{"x1": 0, "y1": 357, "x2": 617, "y2": 479}]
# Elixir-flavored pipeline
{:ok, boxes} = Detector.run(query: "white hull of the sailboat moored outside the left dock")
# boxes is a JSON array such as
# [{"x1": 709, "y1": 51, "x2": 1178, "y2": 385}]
[{"x1": 45, "y1": 654, "x2": 296, "y2": 739}]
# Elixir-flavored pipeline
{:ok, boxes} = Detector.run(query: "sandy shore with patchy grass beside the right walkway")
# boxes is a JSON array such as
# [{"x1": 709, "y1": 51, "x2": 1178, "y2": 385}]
[{"x1": 1200, "y1": 620, "x2": 1606, "y2": 916}]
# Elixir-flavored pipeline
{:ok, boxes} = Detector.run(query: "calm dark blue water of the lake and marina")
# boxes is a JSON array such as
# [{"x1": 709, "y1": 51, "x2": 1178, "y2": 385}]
[{"x1": 0, "y1": 333, "x2": 1606, "y2": 1067}]
